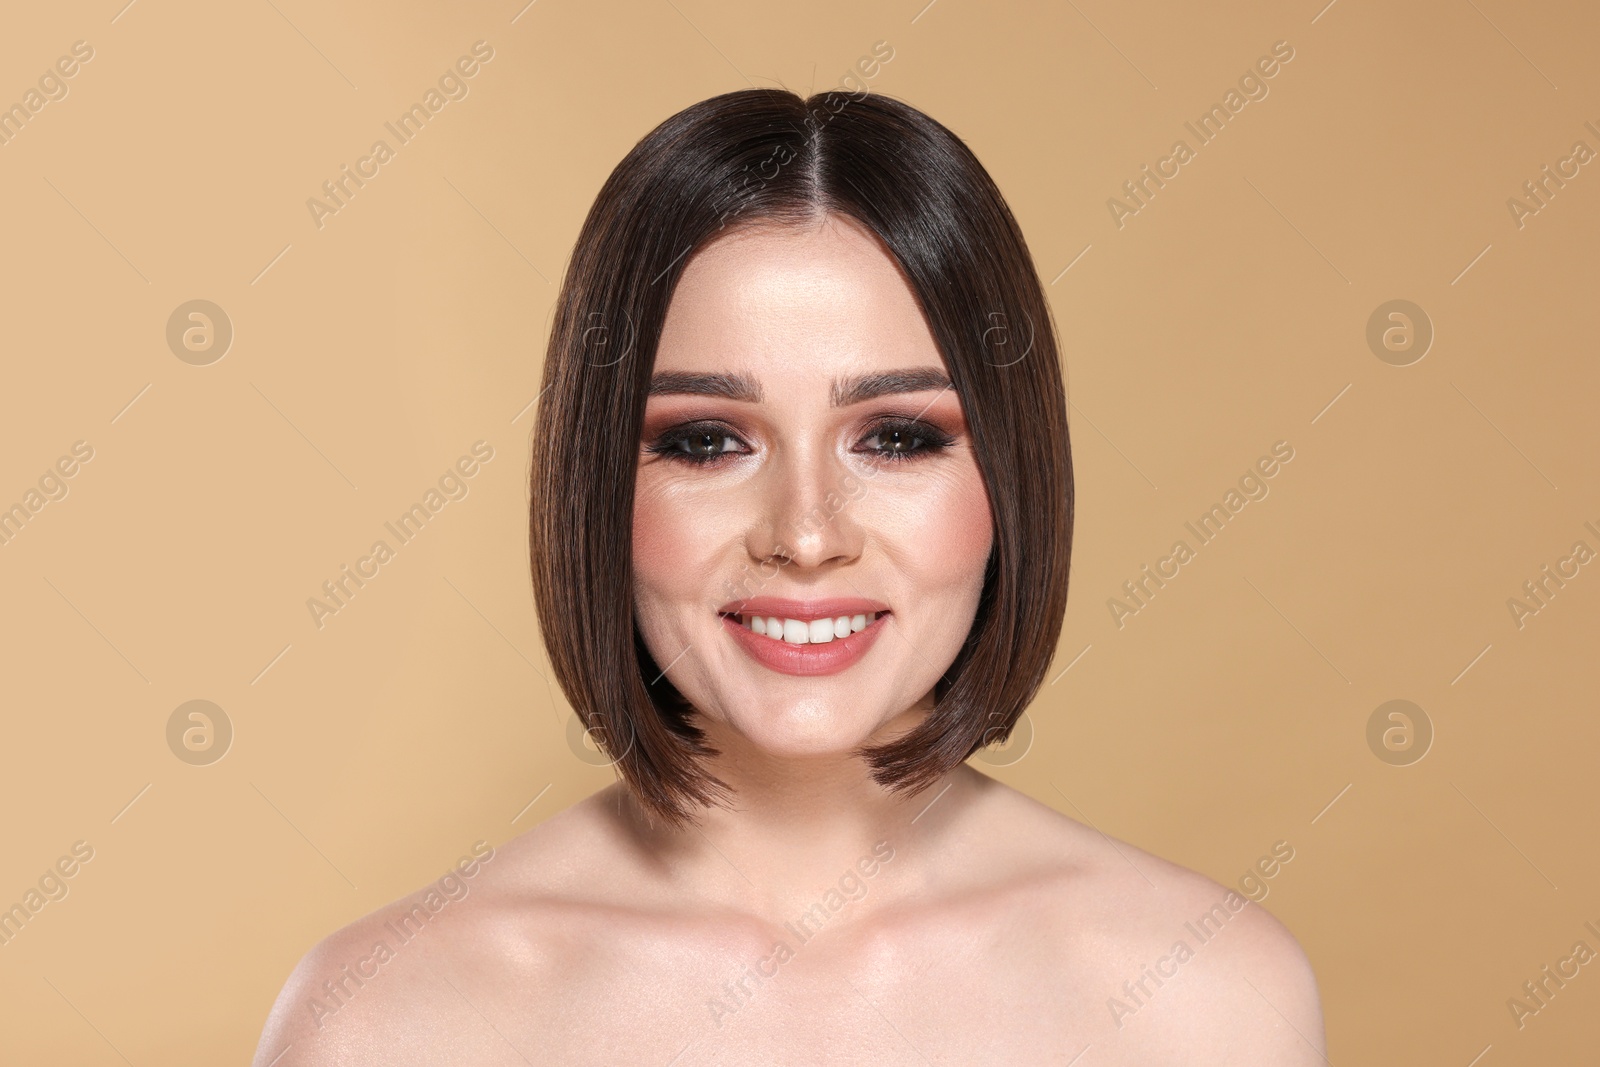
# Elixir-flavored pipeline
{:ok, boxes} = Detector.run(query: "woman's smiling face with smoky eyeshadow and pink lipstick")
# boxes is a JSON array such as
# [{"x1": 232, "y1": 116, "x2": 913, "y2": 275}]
[{"x1": 634, "y1": 216, "x2": 992, "y2": 755}]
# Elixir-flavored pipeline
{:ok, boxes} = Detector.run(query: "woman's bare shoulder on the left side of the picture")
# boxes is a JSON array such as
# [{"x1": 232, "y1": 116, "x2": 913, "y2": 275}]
[{"x1": 253, "y1": 797, "x2": 630, "y2": 1067}]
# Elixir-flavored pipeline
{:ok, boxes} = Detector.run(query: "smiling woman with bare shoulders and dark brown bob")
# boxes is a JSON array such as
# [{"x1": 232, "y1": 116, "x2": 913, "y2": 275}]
[{"x1": 256, "y1": 90, "x2": 1323, "y2": 1067}]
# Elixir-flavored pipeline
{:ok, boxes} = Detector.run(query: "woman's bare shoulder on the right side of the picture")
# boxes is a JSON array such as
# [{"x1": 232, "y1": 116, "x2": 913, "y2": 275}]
[{"x1": 960, "y1": 777, "x2": 1326, "y2": 1064}]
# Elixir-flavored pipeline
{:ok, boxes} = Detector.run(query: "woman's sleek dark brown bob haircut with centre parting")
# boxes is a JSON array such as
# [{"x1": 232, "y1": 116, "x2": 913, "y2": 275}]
[{"x1": 530, "y1": 90, "x2": 1072, "y2": 824}]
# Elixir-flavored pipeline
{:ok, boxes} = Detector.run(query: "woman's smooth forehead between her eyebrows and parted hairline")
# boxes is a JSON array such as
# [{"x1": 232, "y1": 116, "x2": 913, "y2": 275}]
[{"x1": 656, "y1": 216, "x2": 942, "y2": 381}]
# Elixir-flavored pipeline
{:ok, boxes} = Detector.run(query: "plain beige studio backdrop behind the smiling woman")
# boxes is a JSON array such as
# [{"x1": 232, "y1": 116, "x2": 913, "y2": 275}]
[{"x1": 0, "y1": 0, "x2": 1600, "y2": 1067}]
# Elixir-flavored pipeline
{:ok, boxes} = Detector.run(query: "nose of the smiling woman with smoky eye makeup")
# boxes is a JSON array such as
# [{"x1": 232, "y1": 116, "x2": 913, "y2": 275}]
[{"x1": 747, "y1": 450, "x2": 866, "y2": 568}]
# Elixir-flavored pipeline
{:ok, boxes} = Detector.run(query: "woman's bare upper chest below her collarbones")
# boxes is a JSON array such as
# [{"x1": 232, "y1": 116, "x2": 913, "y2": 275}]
[{"x1": 486, "y1": 923, "x2": 1160, "y2": 1067}]
